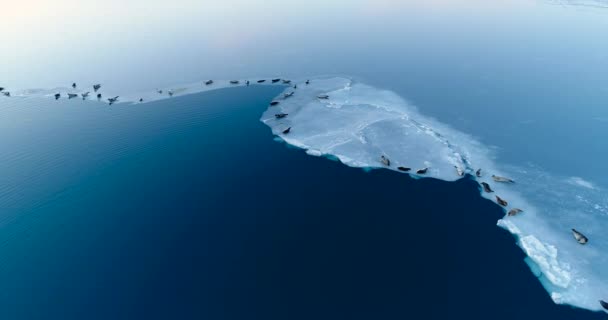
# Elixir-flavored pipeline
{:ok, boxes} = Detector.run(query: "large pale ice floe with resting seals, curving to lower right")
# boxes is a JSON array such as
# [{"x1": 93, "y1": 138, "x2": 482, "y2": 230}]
[{"x1": 261, "y1": 78, "x2": 608, "y2": 310}]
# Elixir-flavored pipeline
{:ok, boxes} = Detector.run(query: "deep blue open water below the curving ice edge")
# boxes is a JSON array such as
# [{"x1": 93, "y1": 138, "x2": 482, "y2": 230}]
[{"x1": 0, "y1": 87, "x2": 605, "y2": 320}]
